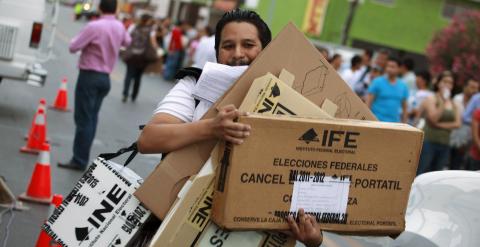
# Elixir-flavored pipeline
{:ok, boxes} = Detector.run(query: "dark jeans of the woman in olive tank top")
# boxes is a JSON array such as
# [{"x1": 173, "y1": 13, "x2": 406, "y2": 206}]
[{"x1": 417, "y1": 141, "x2": 450, "y2": 175}]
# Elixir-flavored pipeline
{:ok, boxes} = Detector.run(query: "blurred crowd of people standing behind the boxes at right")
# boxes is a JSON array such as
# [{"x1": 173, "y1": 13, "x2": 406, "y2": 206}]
[{"x1": 320, "y1": 49, "x2": 480, "y2": 174}]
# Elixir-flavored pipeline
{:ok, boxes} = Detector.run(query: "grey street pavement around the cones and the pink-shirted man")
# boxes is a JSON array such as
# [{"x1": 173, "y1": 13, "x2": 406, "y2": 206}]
[{"x1": 0, "y1": 3, "x2": 174, "y2": 246}]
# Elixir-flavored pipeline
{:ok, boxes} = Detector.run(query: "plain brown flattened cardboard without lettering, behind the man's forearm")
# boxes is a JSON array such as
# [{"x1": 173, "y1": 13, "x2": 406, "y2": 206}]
[{"x1": 135, "y1": 24, "x2": 376, "y2": 219}]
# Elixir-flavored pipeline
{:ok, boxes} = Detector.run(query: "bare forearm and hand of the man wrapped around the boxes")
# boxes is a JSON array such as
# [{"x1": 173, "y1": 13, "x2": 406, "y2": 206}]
[{"x1": 138, "y1": 105, "x2": 251, "y2": 153}]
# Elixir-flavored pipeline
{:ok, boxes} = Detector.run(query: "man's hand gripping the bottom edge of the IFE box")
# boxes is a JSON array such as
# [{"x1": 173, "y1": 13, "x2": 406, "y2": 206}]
[{"x1": 288, "y1": 209, "x2": 323, "y2": 247}]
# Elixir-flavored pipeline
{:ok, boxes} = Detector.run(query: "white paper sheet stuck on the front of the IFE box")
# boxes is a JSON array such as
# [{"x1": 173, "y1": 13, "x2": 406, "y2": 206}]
[{"x1": 290, "y1": 176, "x2": 350, "y2": 214}]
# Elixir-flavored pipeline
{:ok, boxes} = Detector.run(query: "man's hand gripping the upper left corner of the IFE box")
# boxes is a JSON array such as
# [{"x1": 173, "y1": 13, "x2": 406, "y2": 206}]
[{"x1": 210, "y1": 105, "x2": 251, "y2": 144}]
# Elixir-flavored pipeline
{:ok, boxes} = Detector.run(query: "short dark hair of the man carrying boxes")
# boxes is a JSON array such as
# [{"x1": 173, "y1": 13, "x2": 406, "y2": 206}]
[{"x1": 215, "y1": 9, "x2": 272, "y2": 58}]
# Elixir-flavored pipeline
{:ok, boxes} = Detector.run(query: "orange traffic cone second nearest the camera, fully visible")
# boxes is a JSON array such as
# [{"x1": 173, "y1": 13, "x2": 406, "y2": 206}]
[{"x1": 19, "y1": 143, "x2": 52, "y2": 203}]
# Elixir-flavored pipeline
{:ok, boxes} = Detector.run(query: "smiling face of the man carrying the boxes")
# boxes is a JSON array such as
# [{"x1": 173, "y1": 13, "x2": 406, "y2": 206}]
[{"x1": 218, "y1": 22, "x2": 262, "y2": 66}]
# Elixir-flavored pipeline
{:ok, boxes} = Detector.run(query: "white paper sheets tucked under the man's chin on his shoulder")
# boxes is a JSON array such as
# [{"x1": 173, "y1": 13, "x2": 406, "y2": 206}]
[{"x1": 193, "y1": 62, "x2": 248, "y2": 103}]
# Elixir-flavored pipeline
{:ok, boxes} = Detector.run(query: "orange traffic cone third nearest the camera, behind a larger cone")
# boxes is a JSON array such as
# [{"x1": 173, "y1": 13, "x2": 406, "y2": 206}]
[{"x1": 20, "y1": 109, "x2": 47, "y2": 154}]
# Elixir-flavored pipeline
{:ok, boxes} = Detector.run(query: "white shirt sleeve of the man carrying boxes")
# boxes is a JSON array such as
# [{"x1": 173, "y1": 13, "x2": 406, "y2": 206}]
[{"x1": 154, "y1": 77, "x2": 195, "y2": 122}]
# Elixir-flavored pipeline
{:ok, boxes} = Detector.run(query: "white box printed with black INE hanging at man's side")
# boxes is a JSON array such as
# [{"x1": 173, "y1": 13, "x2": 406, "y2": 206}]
[{"x1": 43, "y1": 158, "x2": 150, "y2": 247}]
